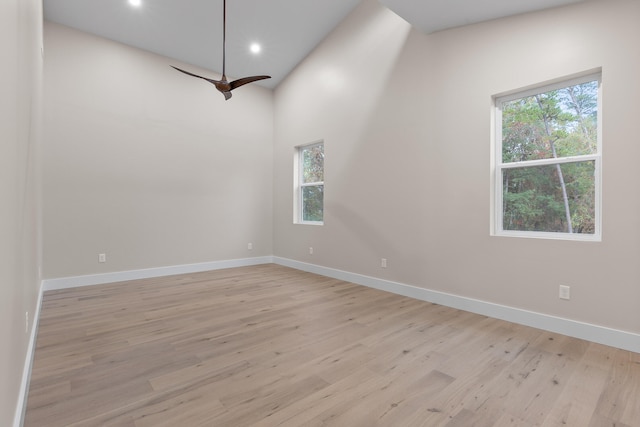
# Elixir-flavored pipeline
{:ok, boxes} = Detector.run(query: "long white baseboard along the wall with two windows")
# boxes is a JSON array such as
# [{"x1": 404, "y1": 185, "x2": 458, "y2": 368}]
[{"x1": 273, "y1": 257, "x2": 640, "y2": 353}]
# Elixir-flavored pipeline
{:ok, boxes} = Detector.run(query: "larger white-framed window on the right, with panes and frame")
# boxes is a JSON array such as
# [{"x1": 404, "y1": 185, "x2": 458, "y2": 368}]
[{"x1": 493, "y1": 74, "x2": 601, "y2": 240}]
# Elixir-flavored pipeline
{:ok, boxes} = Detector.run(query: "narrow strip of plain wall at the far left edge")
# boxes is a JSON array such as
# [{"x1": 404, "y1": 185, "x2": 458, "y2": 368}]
[{"x1": 0, "y1": 0, "x2": 42, "y2": 426}]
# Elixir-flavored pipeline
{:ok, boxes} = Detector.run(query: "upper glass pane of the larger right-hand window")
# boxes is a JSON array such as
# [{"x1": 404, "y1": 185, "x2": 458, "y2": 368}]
[{"x1": 502, "y1": 81, "x2": 598, "y2": 163}]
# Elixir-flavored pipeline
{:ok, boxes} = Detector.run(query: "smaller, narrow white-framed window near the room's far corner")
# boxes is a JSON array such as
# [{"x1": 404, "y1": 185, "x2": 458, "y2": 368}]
[{"x1": 294, "y1": 142, "x2": 324, "y2": 224}]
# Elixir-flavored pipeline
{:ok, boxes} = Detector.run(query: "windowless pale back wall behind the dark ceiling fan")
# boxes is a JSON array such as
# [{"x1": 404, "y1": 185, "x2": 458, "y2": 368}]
[{"x1": 43, "y1": 22, "x2": 273, "y2": 278}]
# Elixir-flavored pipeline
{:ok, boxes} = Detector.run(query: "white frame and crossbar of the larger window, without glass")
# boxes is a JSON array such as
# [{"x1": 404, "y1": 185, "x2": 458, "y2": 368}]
[{"x1": 491, "y1": 70, "x2": 602, "y2": 242}]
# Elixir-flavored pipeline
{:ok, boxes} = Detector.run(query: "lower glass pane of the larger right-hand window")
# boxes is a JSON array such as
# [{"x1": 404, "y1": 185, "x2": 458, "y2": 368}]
[{"x1": 502, "y1": 161, "x2": 595, "y2": 234}]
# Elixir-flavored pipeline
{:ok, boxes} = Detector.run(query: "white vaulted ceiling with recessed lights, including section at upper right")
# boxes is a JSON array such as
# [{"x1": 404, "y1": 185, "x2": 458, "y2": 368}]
[{"x1": 43, "y1": 0, "x2": 584, "y2": 88}]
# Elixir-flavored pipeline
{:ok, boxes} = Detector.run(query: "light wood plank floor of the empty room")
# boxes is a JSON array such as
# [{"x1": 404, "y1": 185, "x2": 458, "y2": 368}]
[{"x1": 25, "y1": 265, "x2": 640, "y2": 427}]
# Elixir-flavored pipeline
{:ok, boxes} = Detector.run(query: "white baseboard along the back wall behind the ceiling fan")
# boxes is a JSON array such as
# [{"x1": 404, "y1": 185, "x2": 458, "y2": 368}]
[{"x1": 44, "y1": 256, "x2": 273, "y2": 291}]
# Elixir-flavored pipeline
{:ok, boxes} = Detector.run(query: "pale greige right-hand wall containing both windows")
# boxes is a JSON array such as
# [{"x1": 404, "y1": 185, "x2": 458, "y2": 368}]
[{"x1": 274, "y1": 0, "x2": 640, "y2": 333}]
